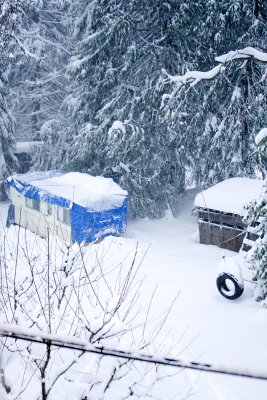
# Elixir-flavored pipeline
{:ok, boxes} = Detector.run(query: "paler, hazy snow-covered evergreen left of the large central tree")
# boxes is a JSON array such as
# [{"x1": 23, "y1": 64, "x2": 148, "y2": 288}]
[{"x1": 10, "y1": 0, "x2": 72, "y2": 169}]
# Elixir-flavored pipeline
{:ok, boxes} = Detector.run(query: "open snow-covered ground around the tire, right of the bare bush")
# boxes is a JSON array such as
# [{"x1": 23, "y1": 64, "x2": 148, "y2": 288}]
[{"x1": 0, "y1": 191, "x2": 267, "y2": 400}]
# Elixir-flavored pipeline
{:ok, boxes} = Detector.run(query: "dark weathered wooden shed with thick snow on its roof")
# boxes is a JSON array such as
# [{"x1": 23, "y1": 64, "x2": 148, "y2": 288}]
[{"x1": 194, "y1": 178, "x2": 263, "y2": 252}]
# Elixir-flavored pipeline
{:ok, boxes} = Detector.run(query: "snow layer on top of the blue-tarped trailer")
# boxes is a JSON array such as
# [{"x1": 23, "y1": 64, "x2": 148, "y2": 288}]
[{"x1": 8, "y1": 171, "x2": 127, "y2": 211}]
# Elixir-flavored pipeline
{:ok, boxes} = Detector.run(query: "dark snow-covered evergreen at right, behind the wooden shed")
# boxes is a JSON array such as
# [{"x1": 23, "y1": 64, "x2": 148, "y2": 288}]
[{"x1": 165, "y1": 0, "x2": 267, "y2": 186}]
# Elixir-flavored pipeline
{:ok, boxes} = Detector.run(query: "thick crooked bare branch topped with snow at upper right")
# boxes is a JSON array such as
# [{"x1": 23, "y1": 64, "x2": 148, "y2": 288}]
[{"x1": 163, "y1": 47, "x2": 267, "y2": 87}]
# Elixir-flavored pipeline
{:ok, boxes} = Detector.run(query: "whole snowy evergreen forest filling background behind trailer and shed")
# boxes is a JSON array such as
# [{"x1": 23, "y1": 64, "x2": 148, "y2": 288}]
[{"x1": 0, "y1": 0, "x2": 267, "y2": 217}]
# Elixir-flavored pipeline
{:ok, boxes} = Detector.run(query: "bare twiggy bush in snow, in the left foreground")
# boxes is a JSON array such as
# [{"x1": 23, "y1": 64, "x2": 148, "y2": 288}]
[{"x1": 0, "y1": 226, "x2": 179, "y2": 400}]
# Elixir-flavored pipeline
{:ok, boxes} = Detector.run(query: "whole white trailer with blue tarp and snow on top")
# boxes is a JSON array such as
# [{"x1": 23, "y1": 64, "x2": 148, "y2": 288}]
[{"x1": 5, "y1": 171, "x2": 128, "y2": 243}]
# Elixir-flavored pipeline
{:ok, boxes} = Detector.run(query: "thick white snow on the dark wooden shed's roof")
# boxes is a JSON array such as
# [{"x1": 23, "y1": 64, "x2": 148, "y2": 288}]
[{"x1": 194, "y1": 178, "x2": 264, "y2": 215}]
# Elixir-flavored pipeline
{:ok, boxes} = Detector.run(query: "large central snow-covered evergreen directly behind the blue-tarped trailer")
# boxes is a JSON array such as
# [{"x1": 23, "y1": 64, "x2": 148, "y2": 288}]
[{"x1": 69, "y1": 0, "x2": 203, "y2": 217}]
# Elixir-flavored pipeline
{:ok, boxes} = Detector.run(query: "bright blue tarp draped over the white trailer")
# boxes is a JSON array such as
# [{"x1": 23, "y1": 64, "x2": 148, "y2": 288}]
[{"x1": 5, "y1": 171, "x2": 128, "y2": 243}]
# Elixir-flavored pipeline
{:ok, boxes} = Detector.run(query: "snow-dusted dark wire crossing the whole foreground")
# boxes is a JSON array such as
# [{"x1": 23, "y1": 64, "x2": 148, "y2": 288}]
[{"x1": 0, "y1": 324, "x2": 267, "y2": 380}]
